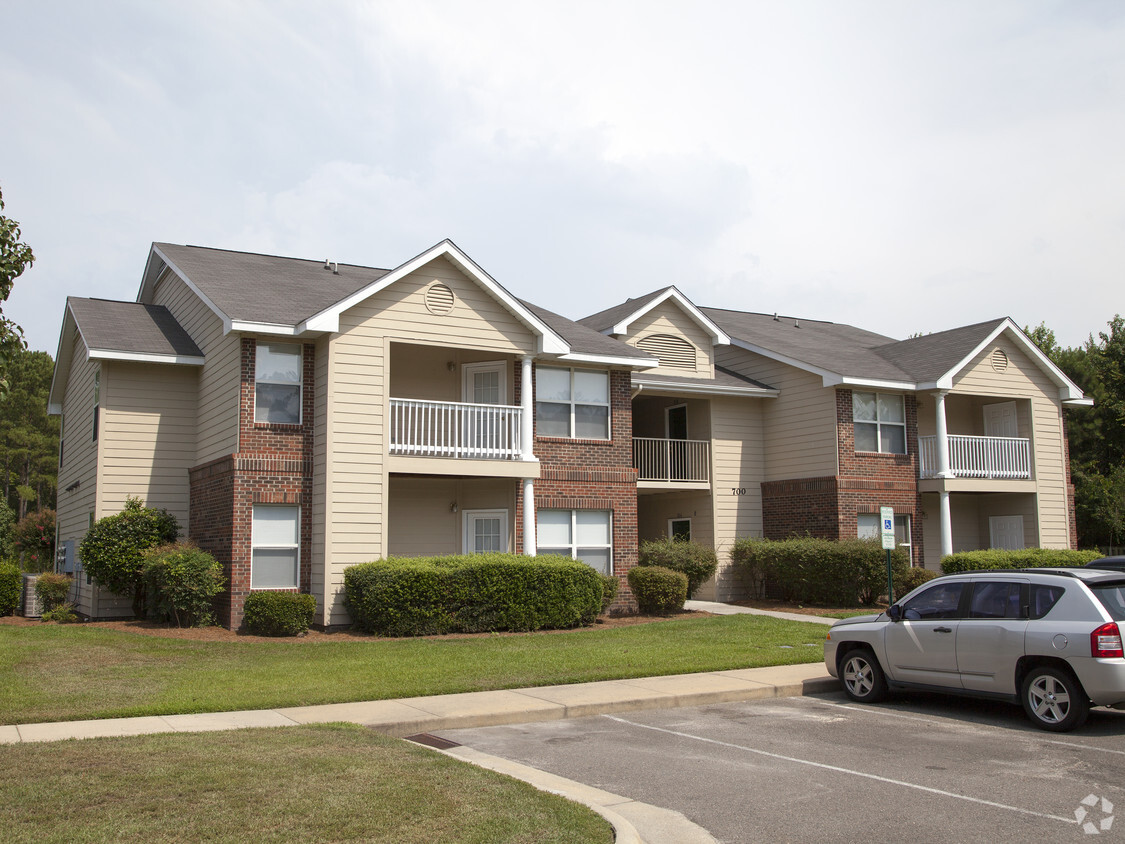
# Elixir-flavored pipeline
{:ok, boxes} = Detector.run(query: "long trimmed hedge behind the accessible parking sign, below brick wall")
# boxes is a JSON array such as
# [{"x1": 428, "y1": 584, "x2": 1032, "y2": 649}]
[{"x1": 730, "y1": 537, "x2": 910, "y2": 607}]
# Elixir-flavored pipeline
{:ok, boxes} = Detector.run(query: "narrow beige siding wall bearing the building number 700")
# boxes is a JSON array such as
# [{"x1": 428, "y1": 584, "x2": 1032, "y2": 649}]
[{"x1": 711, "y1": 397, "x2": 770, "y2": 601}]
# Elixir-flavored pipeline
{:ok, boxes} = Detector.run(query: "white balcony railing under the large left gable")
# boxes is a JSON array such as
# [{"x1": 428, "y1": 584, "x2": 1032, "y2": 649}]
[{"x1": 390, "y1": 398, "x2": 523, "y2": 460}]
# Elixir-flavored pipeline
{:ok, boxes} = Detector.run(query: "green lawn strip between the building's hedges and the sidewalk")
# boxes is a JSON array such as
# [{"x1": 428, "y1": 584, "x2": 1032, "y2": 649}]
[{"x1": 0, "y1": 616, "x2": 826, "y2": 729}]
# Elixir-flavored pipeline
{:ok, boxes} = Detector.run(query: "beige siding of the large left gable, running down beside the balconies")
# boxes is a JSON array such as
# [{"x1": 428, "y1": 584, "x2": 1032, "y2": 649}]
[{"x1": 324, "y1": 259, "x2": 537, "y2": 623}]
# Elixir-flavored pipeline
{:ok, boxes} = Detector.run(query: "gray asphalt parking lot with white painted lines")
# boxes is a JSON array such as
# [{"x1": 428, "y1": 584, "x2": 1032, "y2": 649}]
[{"x1": 440, "y1": 692, "x2": 1125, "y2": 844}]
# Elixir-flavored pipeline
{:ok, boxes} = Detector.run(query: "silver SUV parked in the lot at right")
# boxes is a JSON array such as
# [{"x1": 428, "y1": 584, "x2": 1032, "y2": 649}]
[{"x1": 825, "y1": 568, "x2": 1125, "y2": 731}]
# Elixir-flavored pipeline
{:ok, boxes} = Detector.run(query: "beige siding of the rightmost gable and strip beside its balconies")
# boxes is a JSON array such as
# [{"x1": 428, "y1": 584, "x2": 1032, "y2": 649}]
[{"x1": 953, "y1": 335, "x2": 1070, "y2": 548}]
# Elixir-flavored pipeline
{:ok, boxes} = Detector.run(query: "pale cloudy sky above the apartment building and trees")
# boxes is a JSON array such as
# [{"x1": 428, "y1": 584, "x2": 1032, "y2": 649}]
[{"x1": 0, "y1": 0, "x2": 1125, "y2": 354}]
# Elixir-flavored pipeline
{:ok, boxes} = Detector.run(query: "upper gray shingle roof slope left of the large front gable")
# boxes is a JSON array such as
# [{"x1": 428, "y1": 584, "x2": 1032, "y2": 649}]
[{"x1": 153, "y1": 243, "x2": 389, "y2": 325}]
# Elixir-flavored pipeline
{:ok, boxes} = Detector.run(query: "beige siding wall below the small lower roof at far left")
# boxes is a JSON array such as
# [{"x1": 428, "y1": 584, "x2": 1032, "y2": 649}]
[{"x1": 98, "y1": 361, "x2": 199, "y2": 533}]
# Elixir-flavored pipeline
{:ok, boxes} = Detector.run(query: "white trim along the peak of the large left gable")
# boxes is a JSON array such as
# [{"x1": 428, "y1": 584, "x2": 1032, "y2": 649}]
[{"x1": 296, "y1": 240, "x2": 570, "y2": 354}]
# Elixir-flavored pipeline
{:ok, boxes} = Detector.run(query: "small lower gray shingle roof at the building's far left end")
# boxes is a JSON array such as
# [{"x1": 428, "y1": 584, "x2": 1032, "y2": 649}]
[{"x1": 66, "y1": 296, "x2": 204, "y2": 358}]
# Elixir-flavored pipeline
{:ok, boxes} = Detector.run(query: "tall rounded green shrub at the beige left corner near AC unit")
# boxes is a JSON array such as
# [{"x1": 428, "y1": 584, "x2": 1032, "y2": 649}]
[{"x1": 79, "y1": 499, "x2": 180, "y2": 616}]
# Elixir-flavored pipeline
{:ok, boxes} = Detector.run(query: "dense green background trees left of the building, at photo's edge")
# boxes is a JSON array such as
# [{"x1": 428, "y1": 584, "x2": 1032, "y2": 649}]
[{"x1": 0, "y1": 350, "x2": 59, "y2": 519}]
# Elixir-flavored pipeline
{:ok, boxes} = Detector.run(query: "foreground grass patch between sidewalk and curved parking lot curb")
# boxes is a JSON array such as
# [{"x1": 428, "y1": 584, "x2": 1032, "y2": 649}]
[{"x1": 0, "y1": 725, "x2": 613, "y2": 844}]
